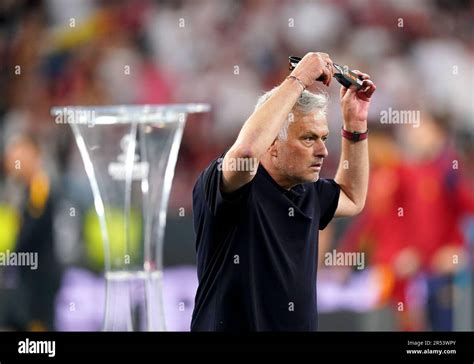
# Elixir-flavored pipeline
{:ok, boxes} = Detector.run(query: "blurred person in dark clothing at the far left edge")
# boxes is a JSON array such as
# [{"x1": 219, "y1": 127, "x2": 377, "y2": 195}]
[{"x1": 2, "y1": 134, "x2": 61, "y2": 331}]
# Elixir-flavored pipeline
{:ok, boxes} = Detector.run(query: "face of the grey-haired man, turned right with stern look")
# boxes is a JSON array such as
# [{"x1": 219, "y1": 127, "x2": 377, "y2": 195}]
[{"x1": 271, "y1": 112, "x2": 329, "y2": 185}]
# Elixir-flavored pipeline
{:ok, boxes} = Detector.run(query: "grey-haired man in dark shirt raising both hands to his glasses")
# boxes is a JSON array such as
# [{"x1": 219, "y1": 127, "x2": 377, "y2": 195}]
[{"x1": 191, "y1": 52, "x2": 375, "y2": 331}]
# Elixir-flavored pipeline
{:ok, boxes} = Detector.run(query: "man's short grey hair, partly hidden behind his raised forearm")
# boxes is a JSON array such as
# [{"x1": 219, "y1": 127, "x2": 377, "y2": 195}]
[{"x1": 255, "y1": 86, "x2": 328, "y2": 140}]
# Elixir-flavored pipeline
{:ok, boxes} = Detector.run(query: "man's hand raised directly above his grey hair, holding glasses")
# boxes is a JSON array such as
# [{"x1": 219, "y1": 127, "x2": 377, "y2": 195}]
[{"x1": 291, "y1": 52, "x2": 334, "y2": 87}]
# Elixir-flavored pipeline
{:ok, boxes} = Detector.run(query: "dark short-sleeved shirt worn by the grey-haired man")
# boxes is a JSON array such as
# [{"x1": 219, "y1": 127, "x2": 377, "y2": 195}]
[{"x1": 191, "y1": 155, "x2": 340, "y2": 331}]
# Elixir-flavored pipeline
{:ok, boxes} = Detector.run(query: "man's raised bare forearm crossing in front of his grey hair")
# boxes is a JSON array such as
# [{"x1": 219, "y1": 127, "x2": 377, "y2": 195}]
[{"x1": 234, "y1": 79, "x2": 302, "y2": 160}]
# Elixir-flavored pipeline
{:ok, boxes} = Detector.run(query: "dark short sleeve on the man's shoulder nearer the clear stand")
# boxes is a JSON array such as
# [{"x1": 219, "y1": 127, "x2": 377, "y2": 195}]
[{"x1": 198, "y1": 154, "x2": 251, "y2": 215}]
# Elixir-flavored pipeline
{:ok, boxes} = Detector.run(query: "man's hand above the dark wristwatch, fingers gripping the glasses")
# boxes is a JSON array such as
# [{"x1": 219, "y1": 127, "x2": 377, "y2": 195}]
[{"x1": 340, "y1": 71, "x2": 376, "y2": 132}]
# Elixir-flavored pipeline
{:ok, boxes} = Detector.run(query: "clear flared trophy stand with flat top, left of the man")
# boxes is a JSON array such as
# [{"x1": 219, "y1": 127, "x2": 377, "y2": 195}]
[{"x1": 51, "y1": 104, "x2": 210, "y2": 331}]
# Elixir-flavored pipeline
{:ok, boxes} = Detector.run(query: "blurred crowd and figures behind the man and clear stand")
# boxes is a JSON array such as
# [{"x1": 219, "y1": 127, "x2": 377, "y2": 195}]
[{"x1": 0, "y1": 0, "x2": 474, "y2": 331}]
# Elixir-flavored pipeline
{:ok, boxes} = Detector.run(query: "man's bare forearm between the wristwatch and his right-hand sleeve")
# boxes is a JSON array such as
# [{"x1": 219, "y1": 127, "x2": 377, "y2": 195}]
[{"x1": 335, "y1": 130, "x2": 369, "y2": 212}]
